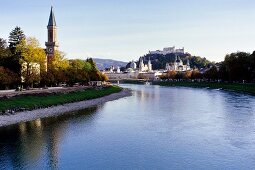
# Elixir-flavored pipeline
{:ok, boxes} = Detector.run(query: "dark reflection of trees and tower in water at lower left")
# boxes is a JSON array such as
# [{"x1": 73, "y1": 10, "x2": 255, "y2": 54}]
[{"x1": 0, "y1": 106, "x2": 99, "y2": 169}]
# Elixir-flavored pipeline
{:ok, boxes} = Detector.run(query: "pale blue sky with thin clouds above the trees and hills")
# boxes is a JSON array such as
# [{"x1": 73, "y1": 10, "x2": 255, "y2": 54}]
[{"x1": 0, "y1": 0, "x2": 255, "y2": 61}]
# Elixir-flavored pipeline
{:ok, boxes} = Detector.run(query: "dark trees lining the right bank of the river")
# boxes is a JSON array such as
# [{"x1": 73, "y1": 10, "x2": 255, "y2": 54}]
[{"x1": 158, "y1": 52, "x2": 255, "y2": 82}]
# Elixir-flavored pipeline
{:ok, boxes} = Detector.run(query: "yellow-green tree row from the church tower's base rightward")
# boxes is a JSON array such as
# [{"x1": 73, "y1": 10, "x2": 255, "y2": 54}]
[{"x1": 42, "y1": 57, "x2": 108, "y2": 86}]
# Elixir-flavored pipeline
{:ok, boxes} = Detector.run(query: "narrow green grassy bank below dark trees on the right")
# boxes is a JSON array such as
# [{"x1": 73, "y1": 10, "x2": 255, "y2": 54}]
[{"x1": 153, "y1": 81, "x2": 255, "y2": 95}]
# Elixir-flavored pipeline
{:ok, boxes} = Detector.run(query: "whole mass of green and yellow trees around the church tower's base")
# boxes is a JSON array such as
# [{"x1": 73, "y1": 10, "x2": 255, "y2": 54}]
[{"x1": 0, "y1": 27, "x2": 108, "y2": 89}]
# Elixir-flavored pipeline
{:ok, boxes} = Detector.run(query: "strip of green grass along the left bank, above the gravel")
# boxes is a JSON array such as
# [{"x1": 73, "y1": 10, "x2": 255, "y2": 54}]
[{"x1": 0, "y1": 86, "x2": 122, "y2": 111}]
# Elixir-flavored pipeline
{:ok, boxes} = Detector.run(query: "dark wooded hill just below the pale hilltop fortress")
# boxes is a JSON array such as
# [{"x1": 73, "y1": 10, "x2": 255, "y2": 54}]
[{"x1": 126, "y1": 53, "x2": 213, "y2": 70}]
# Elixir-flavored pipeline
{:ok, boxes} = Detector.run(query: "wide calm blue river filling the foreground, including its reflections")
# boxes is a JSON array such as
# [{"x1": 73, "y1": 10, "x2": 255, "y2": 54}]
[{"x1": 0, "y1": 85, "x2": 255, "y2": 169}]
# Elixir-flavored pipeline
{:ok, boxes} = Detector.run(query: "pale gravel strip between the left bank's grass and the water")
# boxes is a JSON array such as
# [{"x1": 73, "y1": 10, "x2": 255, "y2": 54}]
[{"x1": 0, "y1": 89, "x2": 132, "y2": 128}]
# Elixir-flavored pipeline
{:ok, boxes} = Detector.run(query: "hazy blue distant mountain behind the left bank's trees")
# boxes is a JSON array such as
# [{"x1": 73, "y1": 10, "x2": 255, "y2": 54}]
[{"x1": 93, "y1": 58, "x2": 127, "y2": 70}]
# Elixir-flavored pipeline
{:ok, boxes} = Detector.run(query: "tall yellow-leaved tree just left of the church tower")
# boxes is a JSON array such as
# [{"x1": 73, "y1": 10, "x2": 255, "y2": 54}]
[{"x1": 17, "y1": 37, "x2": 46, "y2": 86}]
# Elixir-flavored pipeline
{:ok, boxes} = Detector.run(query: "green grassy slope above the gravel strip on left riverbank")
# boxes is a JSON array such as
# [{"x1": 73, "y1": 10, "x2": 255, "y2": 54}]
[{"x1": 0, "y1": 86, "x2": 122, "y2": 114}]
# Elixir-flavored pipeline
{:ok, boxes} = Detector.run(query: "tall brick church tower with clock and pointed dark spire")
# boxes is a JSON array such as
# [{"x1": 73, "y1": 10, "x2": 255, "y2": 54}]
[{"x1": 45, "y1": 7, "x2": 58, "y2": 64}]
